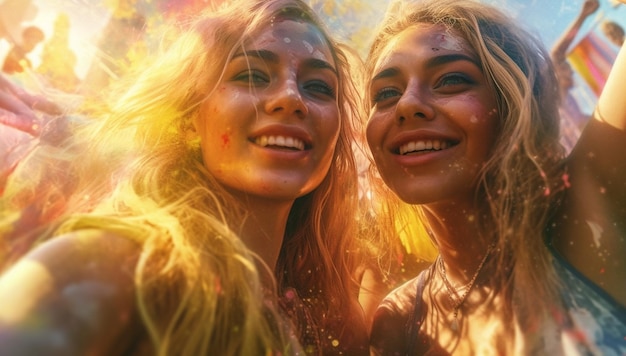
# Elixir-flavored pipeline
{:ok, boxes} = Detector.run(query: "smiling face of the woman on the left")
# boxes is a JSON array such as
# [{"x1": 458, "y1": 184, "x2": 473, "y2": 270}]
[{"x1": 194, "y1": 20, "x2": 340, "y2": 200}]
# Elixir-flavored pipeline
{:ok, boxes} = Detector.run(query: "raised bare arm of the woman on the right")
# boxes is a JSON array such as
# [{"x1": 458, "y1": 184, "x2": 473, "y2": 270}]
[{"x1": 555, "y1": 39, "x2": 626, "y2": 307}]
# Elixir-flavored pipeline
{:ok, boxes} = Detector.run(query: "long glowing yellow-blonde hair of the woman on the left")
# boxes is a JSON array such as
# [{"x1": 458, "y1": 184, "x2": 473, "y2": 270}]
[{"x1": 0, "y1": 0, "x2": 359, "y2": 355}]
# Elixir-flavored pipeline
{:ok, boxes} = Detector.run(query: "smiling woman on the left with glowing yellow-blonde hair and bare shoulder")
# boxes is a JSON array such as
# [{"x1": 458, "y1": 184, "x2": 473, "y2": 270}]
[{"x1": 0, "y1": 0, "x2": 368, "y2": 356}]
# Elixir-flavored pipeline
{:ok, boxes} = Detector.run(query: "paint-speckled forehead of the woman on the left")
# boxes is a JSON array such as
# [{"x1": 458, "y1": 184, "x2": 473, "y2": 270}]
[{"x1": 245, "y1": 19, "x2": 334, "y2": 63}]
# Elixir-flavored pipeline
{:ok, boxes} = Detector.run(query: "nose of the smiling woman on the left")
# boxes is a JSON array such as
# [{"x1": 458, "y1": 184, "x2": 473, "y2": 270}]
[{"x1": 265, "y1": 78, "x2": 309, "y2": 118}]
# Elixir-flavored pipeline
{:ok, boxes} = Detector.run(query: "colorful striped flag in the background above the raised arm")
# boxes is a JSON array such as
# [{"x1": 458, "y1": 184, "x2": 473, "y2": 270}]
[{"x1": 567, "y1": 31, "x2": 617, "y2": 96}]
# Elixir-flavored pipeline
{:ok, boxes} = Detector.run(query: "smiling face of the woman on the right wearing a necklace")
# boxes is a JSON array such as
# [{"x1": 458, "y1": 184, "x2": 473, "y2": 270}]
[{"x1": 367, "y1": 24, "x2": 498, "y2": 204}]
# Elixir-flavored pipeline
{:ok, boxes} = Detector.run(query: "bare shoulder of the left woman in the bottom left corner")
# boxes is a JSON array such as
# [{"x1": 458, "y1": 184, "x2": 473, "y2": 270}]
[{"x1": 0, "y1": 230, "x2": 140, "y2": 355}]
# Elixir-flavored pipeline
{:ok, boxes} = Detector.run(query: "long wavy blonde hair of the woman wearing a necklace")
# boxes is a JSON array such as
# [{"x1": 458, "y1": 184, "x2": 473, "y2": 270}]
[{"x1": 366, "y1": 0, "x2": 564, "y2": 326}]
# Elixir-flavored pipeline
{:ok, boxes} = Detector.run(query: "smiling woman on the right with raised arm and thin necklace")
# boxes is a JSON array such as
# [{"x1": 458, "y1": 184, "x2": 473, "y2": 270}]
[{"x1": 366, "y1": 0, "x2": 626, "y2": 355}]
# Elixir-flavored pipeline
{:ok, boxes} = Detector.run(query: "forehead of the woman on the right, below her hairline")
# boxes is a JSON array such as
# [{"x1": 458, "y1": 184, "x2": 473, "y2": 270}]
[{"x1": 375, "y1": 23, "x2": 475, "y2": 70}]
